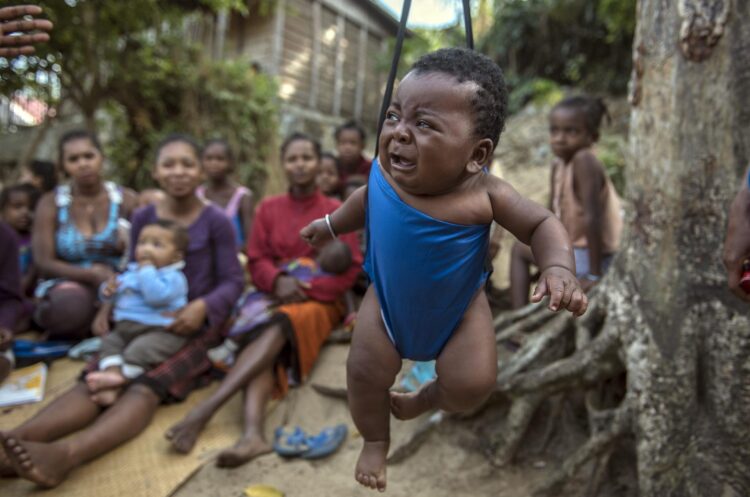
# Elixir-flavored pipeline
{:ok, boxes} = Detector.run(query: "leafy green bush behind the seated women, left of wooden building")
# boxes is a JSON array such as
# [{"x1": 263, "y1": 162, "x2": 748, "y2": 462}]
[{"x1": 108, "y1": 37, "x2": 277, "y2": 192}]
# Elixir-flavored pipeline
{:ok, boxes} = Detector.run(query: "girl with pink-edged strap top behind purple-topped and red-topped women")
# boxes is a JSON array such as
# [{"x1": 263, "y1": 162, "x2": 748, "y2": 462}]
[{"x1": 197, "y1": 139, "x2": 253, "y2": 252}]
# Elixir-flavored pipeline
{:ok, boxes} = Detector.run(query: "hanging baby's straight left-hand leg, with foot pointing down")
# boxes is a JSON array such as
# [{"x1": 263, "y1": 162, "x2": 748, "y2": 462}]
[{"x1": 346, "y1": 287, "x2": 401, "y2": 492}]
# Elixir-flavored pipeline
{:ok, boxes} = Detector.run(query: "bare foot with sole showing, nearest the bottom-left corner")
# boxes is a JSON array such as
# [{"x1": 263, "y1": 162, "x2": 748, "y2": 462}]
[{"x1": 0, "y1": 433, "x2": 72, "y2": 488}]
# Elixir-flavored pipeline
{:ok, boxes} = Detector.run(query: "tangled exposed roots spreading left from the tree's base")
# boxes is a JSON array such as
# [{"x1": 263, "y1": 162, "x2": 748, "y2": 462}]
[{"x1": 490, "y1": 288, "x2": 631, "y2": 497}]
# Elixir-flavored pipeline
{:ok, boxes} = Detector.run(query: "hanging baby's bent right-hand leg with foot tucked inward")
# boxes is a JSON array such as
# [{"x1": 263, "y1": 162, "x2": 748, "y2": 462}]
[{"x1": 391, "y1": 290, "x2": 497, "y2": 419}]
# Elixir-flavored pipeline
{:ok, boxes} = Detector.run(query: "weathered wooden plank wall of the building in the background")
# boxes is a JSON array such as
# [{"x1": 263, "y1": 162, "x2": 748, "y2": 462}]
[{"x1": 220, "y1": 0, "x2": 396, "y2": 148}]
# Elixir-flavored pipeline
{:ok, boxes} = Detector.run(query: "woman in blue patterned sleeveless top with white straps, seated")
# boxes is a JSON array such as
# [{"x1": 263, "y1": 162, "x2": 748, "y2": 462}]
[{"x1": 31, "y1": 131, "x2": 137, "y2": 339}]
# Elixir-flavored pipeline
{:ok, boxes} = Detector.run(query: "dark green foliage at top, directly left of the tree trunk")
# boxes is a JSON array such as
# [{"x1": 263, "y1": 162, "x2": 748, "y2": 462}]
[{"x1": 480, "y1": 0, "x2": 636, "y2": 99}]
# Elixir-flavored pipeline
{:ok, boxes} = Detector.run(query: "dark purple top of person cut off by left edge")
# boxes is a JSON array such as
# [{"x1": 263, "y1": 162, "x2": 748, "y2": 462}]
[{"x1": 0, "y1": 222, "x2": 24, "y2": 330}]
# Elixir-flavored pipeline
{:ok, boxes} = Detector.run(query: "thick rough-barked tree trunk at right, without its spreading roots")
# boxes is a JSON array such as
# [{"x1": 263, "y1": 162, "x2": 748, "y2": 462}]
[{"x1": 624, "y1": 0, "x2": 750, "y2": 490}]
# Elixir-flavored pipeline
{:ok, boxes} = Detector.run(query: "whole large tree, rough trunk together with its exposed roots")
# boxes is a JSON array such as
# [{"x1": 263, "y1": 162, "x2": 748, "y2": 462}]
[{"x1": 484, "y1": 0, "x2": 750, "y2": 497}]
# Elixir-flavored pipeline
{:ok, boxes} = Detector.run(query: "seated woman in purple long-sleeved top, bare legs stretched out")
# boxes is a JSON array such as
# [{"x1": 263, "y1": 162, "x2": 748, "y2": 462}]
[{"x1": 0, "y1": 136, "x2": 242, "y2": 487}]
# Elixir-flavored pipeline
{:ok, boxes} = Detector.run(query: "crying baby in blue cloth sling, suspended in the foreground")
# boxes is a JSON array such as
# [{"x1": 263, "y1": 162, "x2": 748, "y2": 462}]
[{"x1": 301, "y1": 49, "x2": 587, "y2": 491}]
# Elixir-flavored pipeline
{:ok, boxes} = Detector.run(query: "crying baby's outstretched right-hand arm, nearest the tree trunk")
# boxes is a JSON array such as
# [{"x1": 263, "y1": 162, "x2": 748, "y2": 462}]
[{"x1": 487, "y1": 177, "x2": 588, "y2": 316}]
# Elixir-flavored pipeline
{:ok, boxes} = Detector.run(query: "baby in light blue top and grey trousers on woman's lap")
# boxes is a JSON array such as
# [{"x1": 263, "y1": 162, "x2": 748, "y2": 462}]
[{"x1": 86, "y1": 220, "x2": 188, "y2": 405}]
